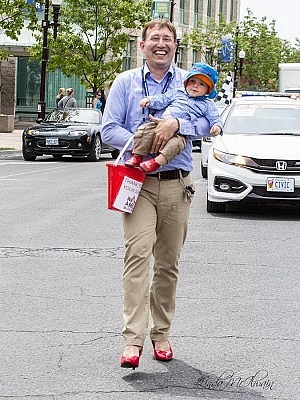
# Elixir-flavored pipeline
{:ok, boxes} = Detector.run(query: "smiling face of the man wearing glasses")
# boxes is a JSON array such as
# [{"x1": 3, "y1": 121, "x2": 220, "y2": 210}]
[{"x1": 140, "y1": 26, "x2": 177, "y2": 67}]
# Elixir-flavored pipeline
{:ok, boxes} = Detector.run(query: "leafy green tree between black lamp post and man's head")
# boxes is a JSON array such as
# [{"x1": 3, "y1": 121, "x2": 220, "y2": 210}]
[{"x1": 31, "y1": 0, "x2": 150, "y2": 93}]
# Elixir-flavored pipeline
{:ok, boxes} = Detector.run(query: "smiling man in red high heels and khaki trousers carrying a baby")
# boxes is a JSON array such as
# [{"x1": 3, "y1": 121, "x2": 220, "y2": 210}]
[{"x1": 101, "y1": 20, "x2": 209, "y2": 369}]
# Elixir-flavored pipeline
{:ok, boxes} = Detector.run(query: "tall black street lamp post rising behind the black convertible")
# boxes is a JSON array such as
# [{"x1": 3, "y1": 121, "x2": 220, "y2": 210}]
[{"x1": 37, "y1": 0, "x2": 62, "y2": 122}]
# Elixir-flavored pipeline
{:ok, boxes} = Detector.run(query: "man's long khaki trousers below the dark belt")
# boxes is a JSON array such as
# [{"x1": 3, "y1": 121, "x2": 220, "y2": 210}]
[{"x1": 122, "y1": 175, "x2": 192, "y2": 346}]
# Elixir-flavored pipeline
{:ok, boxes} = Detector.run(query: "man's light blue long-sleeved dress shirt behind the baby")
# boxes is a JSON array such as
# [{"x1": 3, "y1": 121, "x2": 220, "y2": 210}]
[{"x1": 101, "y1": 64, "x2": 209, "y2": 172}]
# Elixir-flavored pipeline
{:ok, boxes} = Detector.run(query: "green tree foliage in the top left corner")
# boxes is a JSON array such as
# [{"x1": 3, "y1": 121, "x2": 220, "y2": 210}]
[{"x1": 0, "y1": 0, "x2": 35, "y2": 60}]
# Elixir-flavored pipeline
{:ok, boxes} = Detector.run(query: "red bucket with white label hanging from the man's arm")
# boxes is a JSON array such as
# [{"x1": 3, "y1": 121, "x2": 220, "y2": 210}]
[{"x1": 106, "y1": 164, "x2": 146, "y2": 213}]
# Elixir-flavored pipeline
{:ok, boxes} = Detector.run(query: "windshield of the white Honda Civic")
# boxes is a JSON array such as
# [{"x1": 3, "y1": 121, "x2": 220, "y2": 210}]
[{"x1": 224, "y1": 102, "x2": 300, "y2": 135}]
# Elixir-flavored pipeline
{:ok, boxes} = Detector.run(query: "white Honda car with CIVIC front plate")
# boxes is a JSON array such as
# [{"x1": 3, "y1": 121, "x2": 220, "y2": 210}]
[{"x1": 207, "y1": 97, "x2": 300, "y2": 213}]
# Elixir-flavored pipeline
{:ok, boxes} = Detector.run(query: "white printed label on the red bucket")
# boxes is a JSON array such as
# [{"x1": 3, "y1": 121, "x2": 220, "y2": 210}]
[{"x1": 113, "y1": 176, "x2": 143, "y2": 214}]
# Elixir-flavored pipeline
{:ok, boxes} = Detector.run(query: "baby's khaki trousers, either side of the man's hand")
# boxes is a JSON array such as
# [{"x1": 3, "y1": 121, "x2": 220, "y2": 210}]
[{"x1": 133, "y1": 122, "x2": 186, "y2": 162}]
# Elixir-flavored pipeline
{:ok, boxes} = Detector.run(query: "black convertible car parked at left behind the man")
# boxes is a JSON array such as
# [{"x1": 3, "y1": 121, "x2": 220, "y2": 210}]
[{"x1": 22, "y1": 108, "x2": 119, "y2": 161}]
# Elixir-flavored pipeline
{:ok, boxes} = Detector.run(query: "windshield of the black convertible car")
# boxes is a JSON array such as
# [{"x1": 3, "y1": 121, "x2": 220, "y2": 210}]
[{"x1": 44, "y1": 108, "x2": 101, "y2": 124}]
